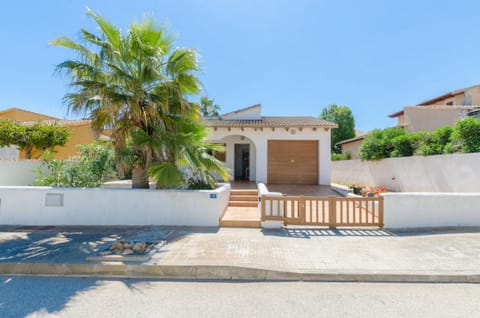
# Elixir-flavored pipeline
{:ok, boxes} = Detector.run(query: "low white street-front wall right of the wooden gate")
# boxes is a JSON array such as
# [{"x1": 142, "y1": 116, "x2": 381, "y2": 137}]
[{"x1": 384, "y1": 193, "x2": 480, "y2": 228}]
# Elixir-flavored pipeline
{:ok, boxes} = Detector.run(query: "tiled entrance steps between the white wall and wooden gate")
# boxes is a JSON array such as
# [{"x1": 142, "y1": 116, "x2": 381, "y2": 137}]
[{"x1": 220, "y1": 189, "x2": 261, "y2": 228}]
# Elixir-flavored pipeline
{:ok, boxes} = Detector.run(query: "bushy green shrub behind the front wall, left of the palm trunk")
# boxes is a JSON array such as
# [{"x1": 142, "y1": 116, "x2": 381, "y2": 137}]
[{"x1": 35, "y1": 142, "x2": 115, "y2": 188}]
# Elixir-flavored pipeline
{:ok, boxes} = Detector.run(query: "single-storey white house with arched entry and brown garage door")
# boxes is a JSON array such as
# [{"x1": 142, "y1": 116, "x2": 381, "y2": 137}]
[{"x1": 204, "y1": 105, "x2": 337, "y2": 185}]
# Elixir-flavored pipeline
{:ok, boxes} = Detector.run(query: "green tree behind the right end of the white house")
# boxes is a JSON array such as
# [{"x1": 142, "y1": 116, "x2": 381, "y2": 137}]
[{"x1": 320, "y1": 104, "x2": 355, "y2": 153}]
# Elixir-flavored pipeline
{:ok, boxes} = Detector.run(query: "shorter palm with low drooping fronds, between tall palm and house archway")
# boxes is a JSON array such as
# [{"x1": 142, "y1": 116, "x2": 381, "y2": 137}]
[{"x1": 132, "y1": 105, "x2": 229, "y2": 188}]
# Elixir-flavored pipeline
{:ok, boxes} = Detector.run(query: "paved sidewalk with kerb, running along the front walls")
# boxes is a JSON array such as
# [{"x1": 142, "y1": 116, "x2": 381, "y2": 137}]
[{"x1": 0, "y1": 227, "x2": 480, "y2": 282}]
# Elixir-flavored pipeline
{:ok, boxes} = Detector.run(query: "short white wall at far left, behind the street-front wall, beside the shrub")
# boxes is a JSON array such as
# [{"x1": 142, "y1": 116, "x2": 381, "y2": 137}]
[{"x1": 0, "y1": 160, "x2": 41, "y2": 186}]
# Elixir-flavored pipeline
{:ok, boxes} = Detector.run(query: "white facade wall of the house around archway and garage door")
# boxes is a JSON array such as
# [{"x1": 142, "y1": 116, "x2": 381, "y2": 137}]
[{"x1": 210, "y1": 128, "x2": 330, "y2": 185}]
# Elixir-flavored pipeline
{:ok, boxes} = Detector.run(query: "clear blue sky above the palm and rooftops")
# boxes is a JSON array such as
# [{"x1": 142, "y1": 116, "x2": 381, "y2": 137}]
[{"x1": 0, "y1": 0, "x2": 480, "y2": 130}]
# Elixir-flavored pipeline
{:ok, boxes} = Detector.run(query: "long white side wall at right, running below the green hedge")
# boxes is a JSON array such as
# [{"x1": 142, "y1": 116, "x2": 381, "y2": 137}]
[{"x1": 332, "y1": 153, "x2": 480, "y2": 193}]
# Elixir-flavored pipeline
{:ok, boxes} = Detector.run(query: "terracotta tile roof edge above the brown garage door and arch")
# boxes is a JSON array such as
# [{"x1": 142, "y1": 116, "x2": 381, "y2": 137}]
[{"x1": 203, "y1": 116, "x2": 338, "y2": 128}]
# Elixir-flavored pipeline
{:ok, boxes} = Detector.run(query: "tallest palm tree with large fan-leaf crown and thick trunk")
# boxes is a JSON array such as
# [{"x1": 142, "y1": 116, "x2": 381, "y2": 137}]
[{"x1": 51, "y1": 10, "x2": 201, "y2": 188}]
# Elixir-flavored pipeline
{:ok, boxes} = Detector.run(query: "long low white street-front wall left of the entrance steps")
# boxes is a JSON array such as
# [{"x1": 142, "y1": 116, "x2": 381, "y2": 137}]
[{"x1": 0, "y1": 184, "x2": 230, "y2": 226}]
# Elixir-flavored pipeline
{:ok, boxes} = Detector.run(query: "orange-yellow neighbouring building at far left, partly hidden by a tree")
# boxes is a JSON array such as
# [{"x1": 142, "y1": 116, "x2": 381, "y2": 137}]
[{"x1": 0, "y1": 108, "x2": 108, "y2": 159}]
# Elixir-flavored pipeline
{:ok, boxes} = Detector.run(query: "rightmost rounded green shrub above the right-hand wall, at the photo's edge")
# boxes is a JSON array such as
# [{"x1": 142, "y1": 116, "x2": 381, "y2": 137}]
[{"x1": 452, "y1": 117, "x2": 480, "y2": 153}]
